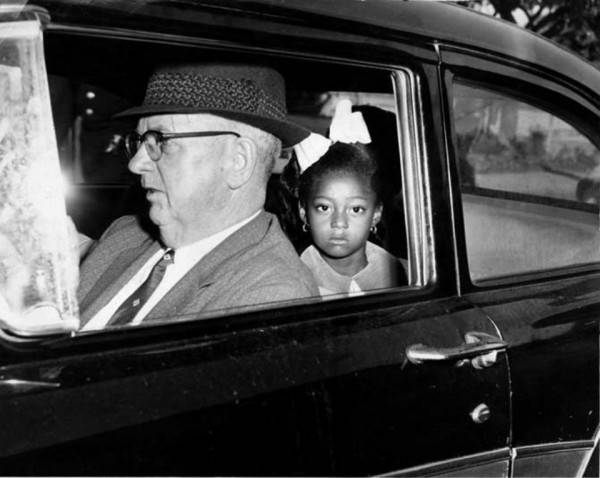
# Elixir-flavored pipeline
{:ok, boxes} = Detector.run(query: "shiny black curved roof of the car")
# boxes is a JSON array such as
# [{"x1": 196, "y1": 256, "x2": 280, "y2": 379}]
[{"x1": 31, "y1": 0, "x2": 600, "y2": 98}]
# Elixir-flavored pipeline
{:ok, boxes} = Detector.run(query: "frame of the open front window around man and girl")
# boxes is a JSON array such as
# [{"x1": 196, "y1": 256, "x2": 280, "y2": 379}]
[{"x1": 38, "y1": 28, "x2": 437, "y2": 336}]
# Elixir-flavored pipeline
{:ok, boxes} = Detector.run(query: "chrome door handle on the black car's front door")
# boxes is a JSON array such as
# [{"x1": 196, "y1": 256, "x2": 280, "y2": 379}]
[{"x1": 406, "y1": 332, "x2": 507, "y2": 366}]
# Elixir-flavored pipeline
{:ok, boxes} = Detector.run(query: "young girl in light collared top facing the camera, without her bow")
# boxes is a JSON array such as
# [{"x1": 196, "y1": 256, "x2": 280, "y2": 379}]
[{"x1": 298, "y1": 142, "x2": 406, "y2": 295}]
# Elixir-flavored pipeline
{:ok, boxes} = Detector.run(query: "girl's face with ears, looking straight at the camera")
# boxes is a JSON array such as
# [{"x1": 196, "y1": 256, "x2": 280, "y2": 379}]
[{"x1": 300, "y1": 173, "x2": 382, "y2": 273}]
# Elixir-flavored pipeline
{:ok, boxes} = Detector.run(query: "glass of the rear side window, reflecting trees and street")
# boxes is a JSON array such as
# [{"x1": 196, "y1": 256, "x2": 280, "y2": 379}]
[{"x1": 453, "y1": 82, "x2": 600, "y2": 281}]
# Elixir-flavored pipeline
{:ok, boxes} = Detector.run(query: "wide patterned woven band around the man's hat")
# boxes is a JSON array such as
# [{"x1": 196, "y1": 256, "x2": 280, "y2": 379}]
[{"x1": 143, "y1": 72, "x2": 286, "y2": 120}]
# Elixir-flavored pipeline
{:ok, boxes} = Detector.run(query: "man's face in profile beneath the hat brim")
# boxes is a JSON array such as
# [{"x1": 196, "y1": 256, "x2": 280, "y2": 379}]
[{"x1": 129, "y1": 114, "x2": 235, "y2": 246}]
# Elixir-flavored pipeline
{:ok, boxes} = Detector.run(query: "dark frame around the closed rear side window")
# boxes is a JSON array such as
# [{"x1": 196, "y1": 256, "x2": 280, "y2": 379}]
[{"x1": 442, "y1": 62, "x2": 600, "y2": 293}]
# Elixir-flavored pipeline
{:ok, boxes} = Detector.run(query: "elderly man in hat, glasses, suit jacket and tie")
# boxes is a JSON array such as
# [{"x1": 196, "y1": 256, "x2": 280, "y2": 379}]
[{"x1": 78, "y1": 64, "x2": 318, "y2": 330}]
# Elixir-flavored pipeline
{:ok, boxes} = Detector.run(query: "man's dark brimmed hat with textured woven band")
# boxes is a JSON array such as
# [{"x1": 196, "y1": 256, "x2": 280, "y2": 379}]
[{"x1": 115, "y1": 63, "x2": 310, "y2": 147}]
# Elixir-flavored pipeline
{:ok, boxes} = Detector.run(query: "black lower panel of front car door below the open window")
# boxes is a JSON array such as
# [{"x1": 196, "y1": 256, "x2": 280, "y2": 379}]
[{"x1": 0, "y1": 301, "x2": 509, "y2": 476}]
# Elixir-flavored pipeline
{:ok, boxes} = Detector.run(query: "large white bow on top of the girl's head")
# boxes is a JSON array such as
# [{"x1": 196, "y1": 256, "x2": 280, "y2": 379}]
[{"x1": 294, "y1": 99, "x2": 371, "y2": 172}]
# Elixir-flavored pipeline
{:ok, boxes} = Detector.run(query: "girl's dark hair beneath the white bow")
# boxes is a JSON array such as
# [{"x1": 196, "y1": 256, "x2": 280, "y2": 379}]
[{"x1": 297, "y1": 143, "x2": 383, "y2": 204}]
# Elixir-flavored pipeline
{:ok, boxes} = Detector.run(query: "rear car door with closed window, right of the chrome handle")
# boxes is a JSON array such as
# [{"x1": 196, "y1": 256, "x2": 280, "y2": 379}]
[{"x1": 442, "y1": 46, "x2": 600, "y2": 476}]
